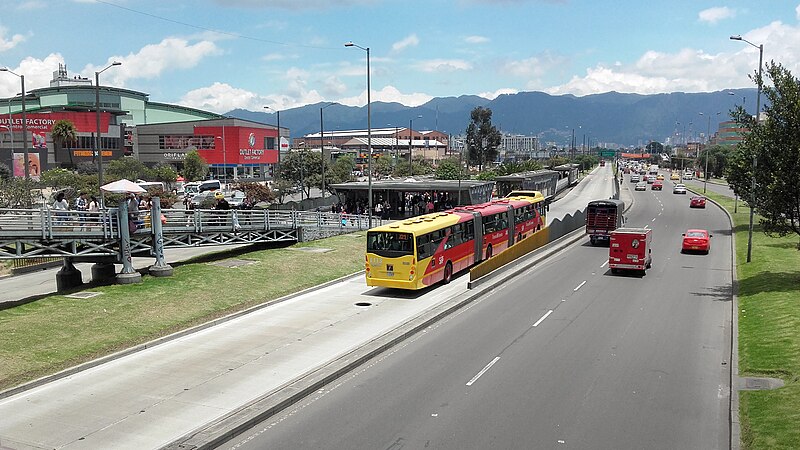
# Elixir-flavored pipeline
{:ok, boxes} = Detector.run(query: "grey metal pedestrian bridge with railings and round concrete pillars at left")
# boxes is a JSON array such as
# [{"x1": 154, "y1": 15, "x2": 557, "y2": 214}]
[{"x1": 0, "y1": 202, "x2": 381, "y2": 290}]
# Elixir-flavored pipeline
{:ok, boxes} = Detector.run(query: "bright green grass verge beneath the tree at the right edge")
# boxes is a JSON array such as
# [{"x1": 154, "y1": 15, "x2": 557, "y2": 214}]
[{"x1": 706, "y1": 192, "x2": 800, "y2": 449}]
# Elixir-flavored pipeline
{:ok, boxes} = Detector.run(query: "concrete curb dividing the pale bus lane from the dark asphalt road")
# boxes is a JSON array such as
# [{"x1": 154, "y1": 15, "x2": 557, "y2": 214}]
[{"x1": 162, "y1": 229, "x2": 585, "y2": 450}]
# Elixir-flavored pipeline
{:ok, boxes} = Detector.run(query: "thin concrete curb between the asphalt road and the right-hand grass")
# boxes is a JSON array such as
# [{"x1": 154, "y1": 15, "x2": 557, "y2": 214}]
[{"x1": 688, "y1": 185, "x2": 742, "y2": 450}]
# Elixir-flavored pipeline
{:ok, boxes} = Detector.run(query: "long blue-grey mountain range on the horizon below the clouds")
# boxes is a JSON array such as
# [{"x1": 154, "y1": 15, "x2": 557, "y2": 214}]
[{"x1": 225, "y1": 88, "x2": 763, "y2": 147}]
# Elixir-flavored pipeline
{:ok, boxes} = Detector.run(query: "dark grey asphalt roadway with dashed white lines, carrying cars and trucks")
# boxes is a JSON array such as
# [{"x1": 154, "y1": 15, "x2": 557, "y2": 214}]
[{"x1": 228, "y1": 168, "x2": 731, "y2": 449}]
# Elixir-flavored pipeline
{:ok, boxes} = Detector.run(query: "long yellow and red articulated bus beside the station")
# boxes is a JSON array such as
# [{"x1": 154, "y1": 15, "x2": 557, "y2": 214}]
[{"x1": 365, "y1": 191, "x2": 547, "y2": 289}]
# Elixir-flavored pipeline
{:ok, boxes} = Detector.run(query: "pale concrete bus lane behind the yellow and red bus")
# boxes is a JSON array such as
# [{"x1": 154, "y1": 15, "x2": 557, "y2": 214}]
[{"x1": 0, "y1": 168, "x2": 620, "y2": 449}]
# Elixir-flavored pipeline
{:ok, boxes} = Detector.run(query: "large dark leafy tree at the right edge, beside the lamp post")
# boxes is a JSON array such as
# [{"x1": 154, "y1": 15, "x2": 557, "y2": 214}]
[{"x1": 727, "y1": 62, "x2": 800, "y2": 244}]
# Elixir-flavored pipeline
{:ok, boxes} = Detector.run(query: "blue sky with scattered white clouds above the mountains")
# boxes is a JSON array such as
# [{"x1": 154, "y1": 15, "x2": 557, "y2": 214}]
[{"x1": 0, "y1": 0, "x2": 800, "y2": 113}]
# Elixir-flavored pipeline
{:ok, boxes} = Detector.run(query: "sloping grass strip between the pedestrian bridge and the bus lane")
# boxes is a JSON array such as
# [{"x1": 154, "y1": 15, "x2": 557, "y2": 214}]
[{"x1": 0, "y1": 233, "x2": 366, "y2": 391}]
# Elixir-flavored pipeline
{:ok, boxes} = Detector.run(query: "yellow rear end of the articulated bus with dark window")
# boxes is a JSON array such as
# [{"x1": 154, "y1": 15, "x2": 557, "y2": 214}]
[{"x1": 364, "y1": 227, "x2": 423, "y2": 289}]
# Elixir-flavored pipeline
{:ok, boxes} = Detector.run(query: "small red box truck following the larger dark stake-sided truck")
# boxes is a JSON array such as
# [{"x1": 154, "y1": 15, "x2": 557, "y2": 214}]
[{"x1": 608, "y1": 228, "x2": 653, "y2": 275}]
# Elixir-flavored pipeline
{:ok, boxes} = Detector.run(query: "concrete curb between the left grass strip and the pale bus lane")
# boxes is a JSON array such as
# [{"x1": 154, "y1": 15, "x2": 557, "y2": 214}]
[{"x1": 0, "y1": 271, "x2": 364, "y2": 399}]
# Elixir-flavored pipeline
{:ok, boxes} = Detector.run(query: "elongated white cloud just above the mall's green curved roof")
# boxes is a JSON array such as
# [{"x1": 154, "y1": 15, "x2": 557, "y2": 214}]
[{"x1": 83, "y1": 38, "x2": 220, "y2": 86}]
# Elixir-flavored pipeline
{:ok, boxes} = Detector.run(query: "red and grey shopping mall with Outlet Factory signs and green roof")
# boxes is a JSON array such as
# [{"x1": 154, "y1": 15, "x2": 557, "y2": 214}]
[{"x1": 0, "y1": 65, "x2": 289, "y2": 180}]
